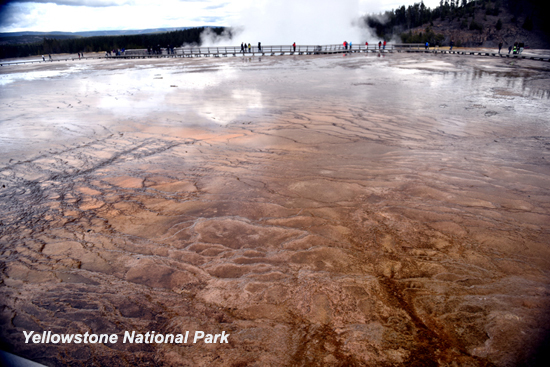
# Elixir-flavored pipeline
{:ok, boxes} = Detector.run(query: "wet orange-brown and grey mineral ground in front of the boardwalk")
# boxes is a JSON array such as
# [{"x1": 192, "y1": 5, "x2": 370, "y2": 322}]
[{"x1": 0, "y1": 54, "x2": 550, "y2": 366}]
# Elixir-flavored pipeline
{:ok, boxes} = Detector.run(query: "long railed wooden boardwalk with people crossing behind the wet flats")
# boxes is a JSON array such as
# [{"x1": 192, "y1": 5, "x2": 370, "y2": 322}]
[{"x1": 0, "y1": 43, "x2": 550, "y2": 66}]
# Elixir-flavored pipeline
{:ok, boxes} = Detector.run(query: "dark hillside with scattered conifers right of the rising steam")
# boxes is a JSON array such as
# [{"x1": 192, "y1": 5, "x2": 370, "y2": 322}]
[{"x1": 363, "y1": 0, "x2": 550, "y2": 48}]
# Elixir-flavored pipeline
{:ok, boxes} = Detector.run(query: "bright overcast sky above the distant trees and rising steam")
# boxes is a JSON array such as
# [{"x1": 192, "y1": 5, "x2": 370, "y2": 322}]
[{"x1": 0, "y1": 0, "x2": 439, "y2": 32}]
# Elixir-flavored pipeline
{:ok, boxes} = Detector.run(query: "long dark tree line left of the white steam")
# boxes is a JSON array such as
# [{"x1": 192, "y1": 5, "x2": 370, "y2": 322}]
[{"x1": 0, "y1": 27, "x2": 225, "y2": 58}]
